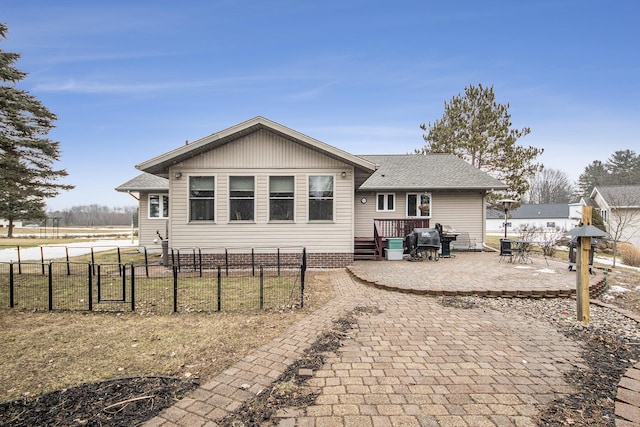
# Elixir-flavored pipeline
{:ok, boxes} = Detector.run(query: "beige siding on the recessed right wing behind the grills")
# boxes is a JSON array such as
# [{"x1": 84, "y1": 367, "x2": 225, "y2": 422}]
[{"x1": 354, "y1": 191, "x2": 485, "y2": 242}]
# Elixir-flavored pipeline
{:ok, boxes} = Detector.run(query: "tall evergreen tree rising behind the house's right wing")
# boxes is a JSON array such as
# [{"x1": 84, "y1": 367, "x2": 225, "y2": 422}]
[{"x1": 416, "y1": 84, "x2": 543, "y2": 197}]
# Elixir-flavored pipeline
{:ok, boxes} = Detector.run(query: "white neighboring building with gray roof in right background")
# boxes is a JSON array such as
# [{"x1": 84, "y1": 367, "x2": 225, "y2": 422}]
[{"x1": 487, "y1": 203, "x2": 582, "y2": 234}]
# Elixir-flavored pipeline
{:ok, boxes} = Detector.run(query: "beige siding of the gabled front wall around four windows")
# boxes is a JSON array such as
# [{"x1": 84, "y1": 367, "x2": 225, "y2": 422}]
[{"x1": 169, "y1": 130, "x2": 353, "y2": 265}]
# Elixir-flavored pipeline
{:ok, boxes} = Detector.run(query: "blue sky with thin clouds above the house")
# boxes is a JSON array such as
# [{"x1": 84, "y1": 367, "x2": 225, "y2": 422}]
[{"x1": 0, "y1": 0, "x2": 640, "y2": 209}]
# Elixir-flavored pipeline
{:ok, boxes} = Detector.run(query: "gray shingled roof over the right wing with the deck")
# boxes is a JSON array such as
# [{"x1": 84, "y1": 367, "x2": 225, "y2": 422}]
[{"x1": 358, "y1": 154, "x2": 507, "y2": 191}]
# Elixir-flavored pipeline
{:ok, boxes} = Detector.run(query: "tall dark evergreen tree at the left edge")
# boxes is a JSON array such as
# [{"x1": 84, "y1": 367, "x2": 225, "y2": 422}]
[{"x1": 0, "y1": 23, "x2": 73, "y2": 237}]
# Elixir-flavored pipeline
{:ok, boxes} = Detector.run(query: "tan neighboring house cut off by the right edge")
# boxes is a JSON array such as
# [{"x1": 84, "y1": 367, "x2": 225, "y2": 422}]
[{"x1": 589, "y1": 185, "x2": 640, "y2": 247}]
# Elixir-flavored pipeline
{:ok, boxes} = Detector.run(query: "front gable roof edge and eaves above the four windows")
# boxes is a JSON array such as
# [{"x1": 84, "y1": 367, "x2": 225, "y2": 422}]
[{"x1": 136, "y1": 116, "x2": 375, "y2": 176}]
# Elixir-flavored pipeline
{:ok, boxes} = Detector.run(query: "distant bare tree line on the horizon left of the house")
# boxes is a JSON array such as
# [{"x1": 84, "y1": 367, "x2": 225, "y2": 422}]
[{"x1": 47, "y1": 205, "x2": 138, "y2": 227}]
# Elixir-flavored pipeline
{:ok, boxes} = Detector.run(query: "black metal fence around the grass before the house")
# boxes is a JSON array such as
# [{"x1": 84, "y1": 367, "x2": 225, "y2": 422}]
[{"x1": 0, "y1": 250, "x2": 306, "y2": 313}]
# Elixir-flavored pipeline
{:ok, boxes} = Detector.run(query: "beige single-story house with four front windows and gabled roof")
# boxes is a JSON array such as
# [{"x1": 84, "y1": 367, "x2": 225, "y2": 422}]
[{"x1": 117, "y1": 117, "x2": 506, "y2": 267}]
